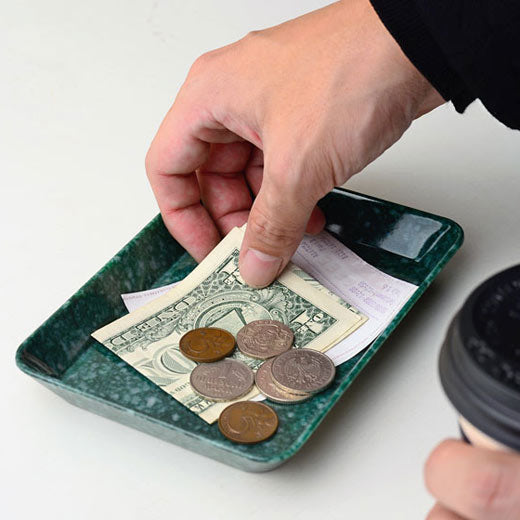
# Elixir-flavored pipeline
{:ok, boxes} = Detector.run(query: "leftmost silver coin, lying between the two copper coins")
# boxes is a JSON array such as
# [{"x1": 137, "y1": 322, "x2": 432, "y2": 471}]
[{"x1": 190, "y1": 359, "x2": 255, "y2": 401}]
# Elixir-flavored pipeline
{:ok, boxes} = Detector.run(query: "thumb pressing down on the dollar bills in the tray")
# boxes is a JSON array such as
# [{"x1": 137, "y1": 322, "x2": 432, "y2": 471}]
[{"x1": 239, "y1": 171, "x2": 317, "y2": 287}]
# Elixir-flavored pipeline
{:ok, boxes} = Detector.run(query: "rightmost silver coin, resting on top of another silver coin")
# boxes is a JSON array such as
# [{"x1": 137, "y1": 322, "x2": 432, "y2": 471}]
[{"x1": 271, "y1": 348, "x2": 336, "y2": 394}]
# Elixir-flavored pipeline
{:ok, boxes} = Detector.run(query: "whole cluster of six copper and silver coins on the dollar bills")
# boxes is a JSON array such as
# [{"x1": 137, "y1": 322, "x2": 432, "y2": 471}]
[{"x1": 179, "y1": 320, "x2": 335, "y2": 444}]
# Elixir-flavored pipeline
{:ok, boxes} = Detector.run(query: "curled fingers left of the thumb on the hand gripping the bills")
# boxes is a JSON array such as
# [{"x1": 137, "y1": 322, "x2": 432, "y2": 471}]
[{"x1": 146, "y1": 100, "x2": 251, "y2": 261}]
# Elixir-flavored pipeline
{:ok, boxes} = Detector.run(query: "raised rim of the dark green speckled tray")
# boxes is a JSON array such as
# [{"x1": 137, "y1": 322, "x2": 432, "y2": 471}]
[{"x1": 15, "y1": 188, "x2": 464, "y2": 469}]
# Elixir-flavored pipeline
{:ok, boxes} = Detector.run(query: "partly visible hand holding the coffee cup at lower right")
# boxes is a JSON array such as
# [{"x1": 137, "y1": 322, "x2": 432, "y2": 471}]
[{"x1": 425, "y1": 440, "x2": 520, "y2": 520}]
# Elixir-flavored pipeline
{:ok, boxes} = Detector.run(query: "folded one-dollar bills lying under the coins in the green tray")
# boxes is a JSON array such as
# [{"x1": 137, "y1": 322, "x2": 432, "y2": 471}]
[{"x1": 92, "y1": 228, "x2": 364, "y2": 423}]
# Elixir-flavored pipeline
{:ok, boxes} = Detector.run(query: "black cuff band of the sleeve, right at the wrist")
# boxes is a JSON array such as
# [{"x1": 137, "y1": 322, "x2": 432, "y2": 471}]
[{"x1": 370, "y1": 0, "x2": 475, "y2": 113}]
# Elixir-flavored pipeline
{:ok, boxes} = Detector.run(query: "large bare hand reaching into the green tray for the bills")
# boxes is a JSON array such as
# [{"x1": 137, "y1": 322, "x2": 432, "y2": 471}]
[{"x1": 146, "y1": 0, "x2": 444, "y2": 287}]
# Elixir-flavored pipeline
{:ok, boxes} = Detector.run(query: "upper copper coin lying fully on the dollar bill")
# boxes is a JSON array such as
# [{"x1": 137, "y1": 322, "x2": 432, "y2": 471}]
[{"x1": 179, "y1": 327, "x2": 235, "y2": 363}]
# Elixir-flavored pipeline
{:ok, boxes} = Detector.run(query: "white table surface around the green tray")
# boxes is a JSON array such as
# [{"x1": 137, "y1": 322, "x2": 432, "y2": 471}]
[{"x1": 0, "y1": 0, "x2": 520, "y2": 520}]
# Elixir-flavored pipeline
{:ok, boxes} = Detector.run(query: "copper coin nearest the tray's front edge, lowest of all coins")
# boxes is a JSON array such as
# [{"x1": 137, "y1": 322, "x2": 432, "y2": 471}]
[{"x1": 218, "y1": 401, "x2": 278, "y2": 444}]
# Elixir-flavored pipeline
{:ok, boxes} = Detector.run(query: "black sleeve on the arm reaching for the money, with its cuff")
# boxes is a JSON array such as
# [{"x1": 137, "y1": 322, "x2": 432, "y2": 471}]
[{"x1": 370, "y1": 0, "x2": 520, "y2": 129}]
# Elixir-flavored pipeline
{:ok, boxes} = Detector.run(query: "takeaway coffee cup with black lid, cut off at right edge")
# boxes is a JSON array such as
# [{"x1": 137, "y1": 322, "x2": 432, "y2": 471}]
[{"x1": 439, "y1": 265, "x2": 520, "y2": 451}]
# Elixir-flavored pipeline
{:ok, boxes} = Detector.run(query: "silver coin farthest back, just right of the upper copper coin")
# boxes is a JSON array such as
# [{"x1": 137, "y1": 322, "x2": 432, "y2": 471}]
[{"x1": 237, "y1": 320, "x2": 294, "y2": 359}]
